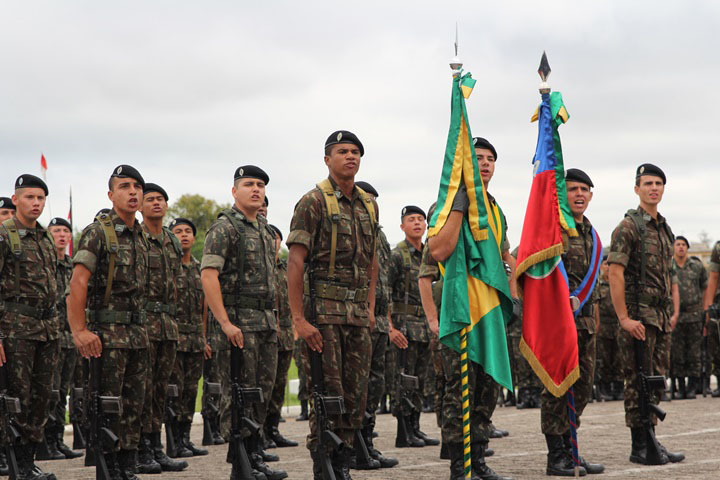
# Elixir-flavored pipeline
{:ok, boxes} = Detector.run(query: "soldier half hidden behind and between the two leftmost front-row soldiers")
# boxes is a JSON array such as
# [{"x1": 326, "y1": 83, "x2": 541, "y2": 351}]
[{"x1": 45, "y1": 217, "x2": 82, "y2": 458}]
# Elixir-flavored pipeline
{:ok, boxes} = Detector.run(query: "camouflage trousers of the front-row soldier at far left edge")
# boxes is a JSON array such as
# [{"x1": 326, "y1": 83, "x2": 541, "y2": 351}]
[{"x1": 5, "y1": 337, "x2": 60, "y2": 445}]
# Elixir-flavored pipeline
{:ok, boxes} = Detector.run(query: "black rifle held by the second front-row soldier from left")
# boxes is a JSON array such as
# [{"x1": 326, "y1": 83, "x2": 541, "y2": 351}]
[{"x1": 87, "y1": 332, "x2": 122, "y2": 480}]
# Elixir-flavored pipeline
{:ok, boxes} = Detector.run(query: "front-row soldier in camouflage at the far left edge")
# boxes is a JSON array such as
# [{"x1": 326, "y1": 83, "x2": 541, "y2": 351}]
[{"x1": 0, "y1": 174, "x2": 59, "y2": 480}]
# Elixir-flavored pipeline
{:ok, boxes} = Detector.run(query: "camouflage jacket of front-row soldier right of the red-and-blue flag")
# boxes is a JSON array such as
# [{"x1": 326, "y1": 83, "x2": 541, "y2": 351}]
[{"x1": 608, "y1": 207, "x2": 673, "y2": 332}]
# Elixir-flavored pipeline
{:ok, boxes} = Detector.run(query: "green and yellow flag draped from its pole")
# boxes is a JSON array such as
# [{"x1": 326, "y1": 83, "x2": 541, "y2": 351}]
[{"x1": 428, "y1": 73, "x2": 513, "y2": 389}]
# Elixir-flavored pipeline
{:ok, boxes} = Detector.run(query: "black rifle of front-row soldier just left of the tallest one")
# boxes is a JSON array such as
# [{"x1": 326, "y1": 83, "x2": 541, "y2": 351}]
[{"x1": 228, "y1": 345, "x2": 263, "y2": 480}]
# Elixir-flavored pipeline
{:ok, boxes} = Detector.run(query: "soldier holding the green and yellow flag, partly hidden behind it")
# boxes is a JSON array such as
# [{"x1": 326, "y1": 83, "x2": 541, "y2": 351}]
[{"x1": 428, "y1": 137, "x2": 517, "y2": 480}]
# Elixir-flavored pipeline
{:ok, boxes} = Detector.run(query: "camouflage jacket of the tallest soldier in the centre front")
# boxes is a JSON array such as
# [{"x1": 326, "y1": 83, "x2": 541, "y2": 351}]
[{"x1": 287, "y1": 179, "x2": 379, "y2": 327}]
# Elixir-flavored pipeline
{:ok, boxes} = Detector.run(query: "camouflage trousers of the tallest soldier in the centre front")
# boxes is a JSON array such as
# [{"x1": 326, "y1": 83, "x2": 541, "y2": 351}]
[{"x1": 302, "y1": 325, "x2": 372, "y2": 450}]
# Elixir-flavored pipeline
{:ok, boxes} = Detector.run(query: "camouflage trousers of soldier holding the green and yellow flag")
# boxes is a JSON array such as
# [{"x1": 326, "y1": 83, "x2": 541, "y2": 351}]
[{"x1": 440, "y1": 345, "x2": 500, "y2": 443}]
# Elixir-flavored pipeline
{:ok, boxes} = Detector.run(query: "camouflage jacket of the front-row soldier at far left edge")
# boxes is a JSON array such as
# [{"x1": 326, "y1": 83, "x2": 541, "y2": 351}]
[{"x1": 0, "y1": 217, "x2": 59, "y2": 341}]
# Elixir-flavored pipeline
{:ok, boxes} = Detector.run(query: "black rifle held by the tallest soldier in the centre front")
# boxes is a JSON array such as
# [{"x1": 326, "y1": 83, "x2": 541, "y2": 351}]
[{"x1": 307, "y1": 270, "x2": 346, "y2": 480}]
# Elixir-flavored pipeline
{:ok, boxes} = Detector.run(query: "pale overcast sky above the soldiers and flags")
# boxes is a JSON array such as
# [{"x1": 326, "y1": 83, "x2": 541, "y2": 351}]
[{"x1": 0, "y1": 0, "x2": 720, "y2": 251}]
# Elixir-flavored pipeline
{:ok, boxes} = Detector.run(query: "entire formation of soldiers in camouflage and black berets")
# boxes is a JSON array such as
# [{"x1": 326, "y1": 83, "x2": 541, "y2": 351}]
[{"x1": 0, "y1": 130, "x2": 720, "y2": 480}]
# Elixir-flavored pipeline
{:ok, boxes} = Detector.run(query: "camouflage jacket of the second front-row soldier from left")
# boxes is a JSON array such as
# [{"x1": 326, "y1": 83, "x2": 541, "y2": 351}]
[{"x1": 73, "y1": 210, "x2": 149, "y2": 348}]
